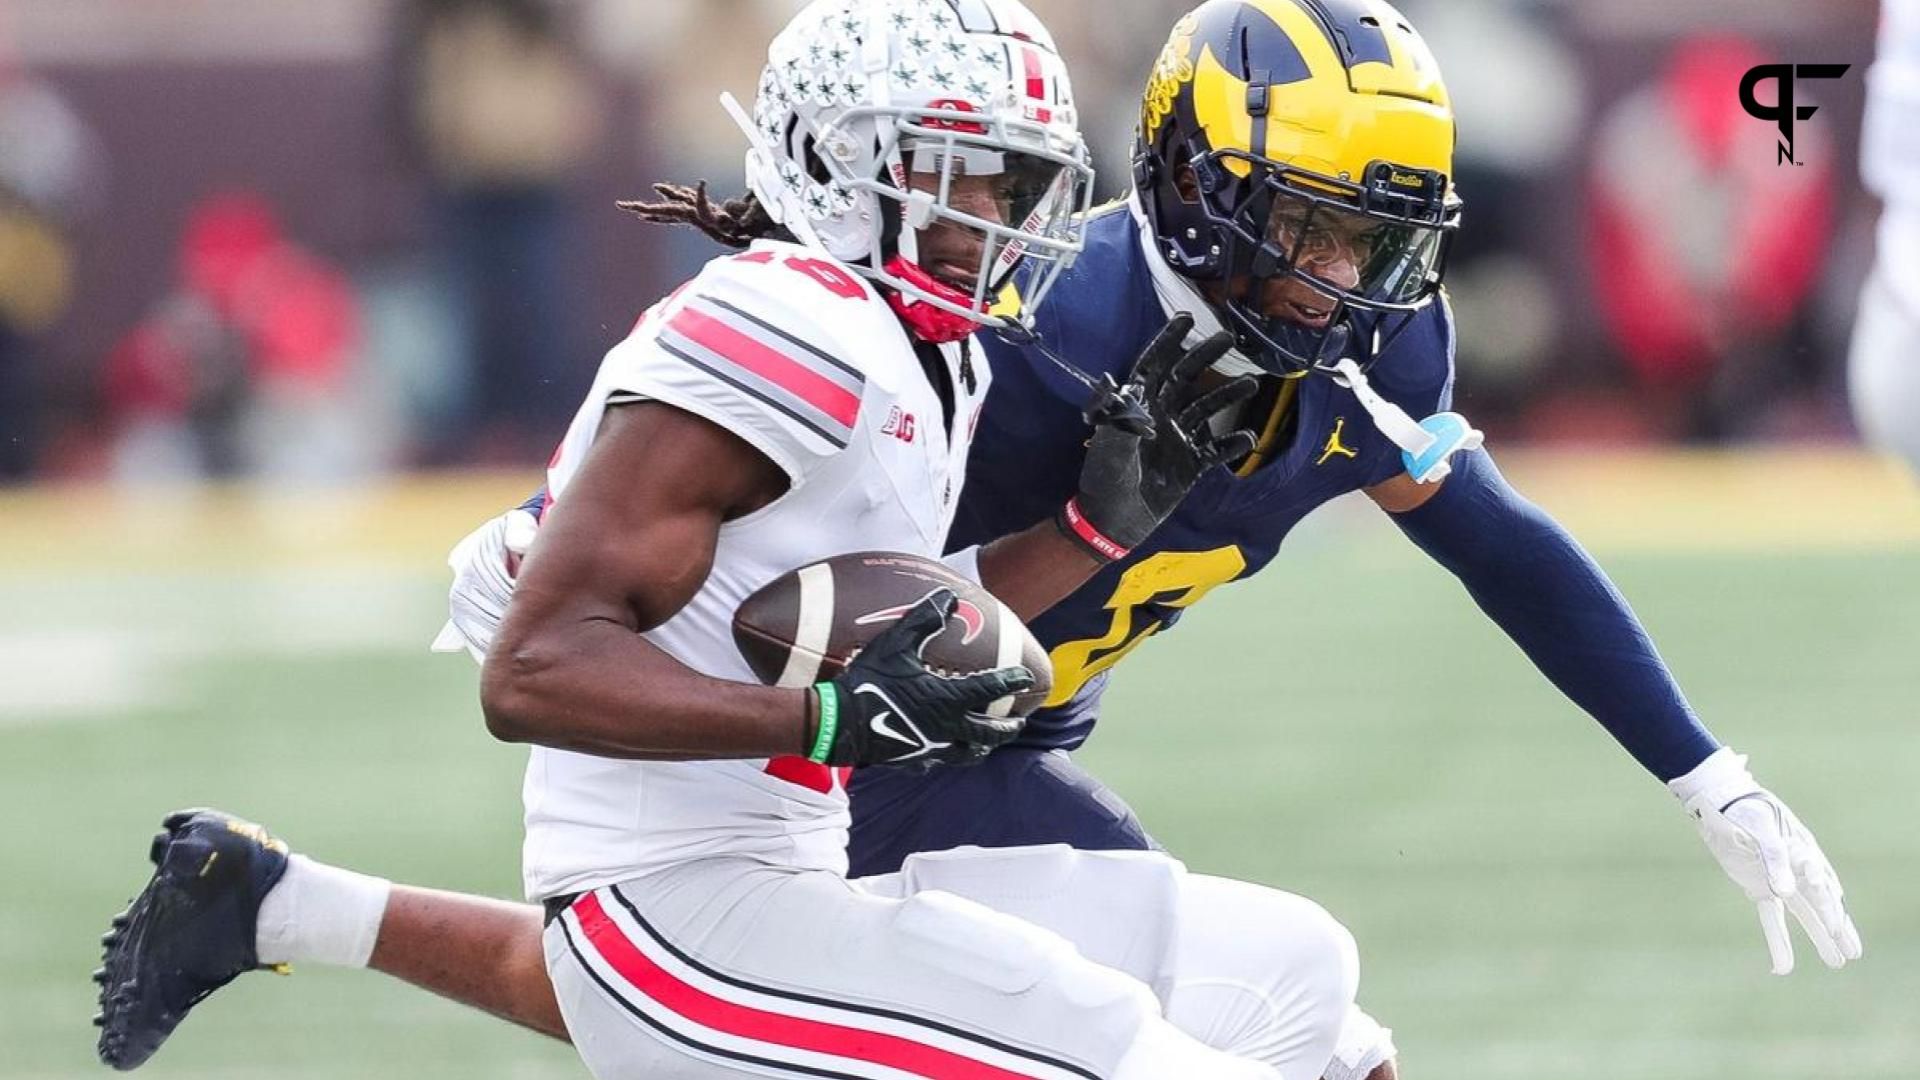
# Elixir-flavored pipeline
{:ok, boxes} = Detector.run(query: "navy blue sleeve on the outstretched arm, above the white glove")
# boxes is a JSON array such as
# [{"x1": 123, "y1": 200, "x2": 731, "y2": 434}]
[{"x1": 1394, "y1": 452, "x2": 1720, "y2": 780}]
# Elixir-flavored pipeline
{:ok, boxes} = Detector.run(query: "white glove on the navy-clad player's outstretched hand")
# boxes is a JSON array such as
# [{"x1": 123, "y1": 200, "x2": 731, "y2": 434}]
[{"x1": 1667, "y1": 748, "x2": 1860, "y2": 974}]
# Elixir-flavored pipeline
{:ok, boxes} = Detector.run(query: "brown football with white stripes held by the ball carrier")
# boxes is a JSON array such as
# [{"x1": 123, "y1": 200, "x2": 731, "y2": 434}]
[{"x1": 733, "y1": 552, "x2": 1054, "y2": 717}]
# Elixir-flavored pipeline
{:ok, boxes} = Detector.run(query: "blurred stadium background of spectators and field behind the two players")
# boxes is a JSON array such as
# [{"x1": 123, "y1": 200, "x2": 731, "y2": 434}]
[{"x1": 0, "y1": 0, "x2": 1920, "y2": 1080}]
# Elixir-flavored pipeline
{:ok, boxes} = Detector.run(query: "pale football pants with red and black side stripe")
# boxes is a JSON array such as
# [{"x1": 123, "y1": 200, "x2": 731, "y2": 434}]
[{"x1": 545, "y1": 846, "x2": 1359, "y2": 1080}]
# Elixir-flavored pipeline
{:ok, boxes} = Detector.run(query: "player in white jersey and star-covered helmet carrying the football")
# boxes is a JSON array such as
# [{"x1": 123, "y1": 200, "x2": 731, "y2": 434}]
[{"x1": 98, "y1": 0, "x2": 1357, "y2": 1080}]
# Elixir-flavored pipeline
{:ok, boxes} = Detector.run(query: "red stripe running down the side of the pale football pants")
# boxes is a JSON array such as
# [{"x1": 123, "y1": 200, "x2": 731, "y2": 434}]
[{"x1": 572, "y1": 892, "x2": 1031, "y2": 1080}]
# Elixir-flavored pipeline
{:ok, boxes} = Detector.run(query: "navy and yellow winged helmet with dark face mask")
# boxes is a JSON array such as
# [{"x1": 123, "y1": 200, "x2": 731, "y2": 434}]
[{"x1": 1135, "y1": 0, "x2": 1459, "y2": 375}]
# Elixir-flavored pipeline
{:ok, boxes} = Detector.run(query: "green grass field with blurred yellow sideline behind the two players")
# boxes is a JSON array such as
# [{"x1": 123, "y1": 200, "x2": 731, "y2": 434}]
[{"x1": 0, "y1": 459, "x2": 1920, "y2": 1080}]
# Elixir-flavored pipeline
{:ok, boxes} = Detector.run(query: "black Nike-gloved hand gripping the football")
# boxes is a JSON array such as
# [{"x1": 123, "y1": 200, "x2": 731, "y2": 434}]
[{"x1": 808, "y1": 588, "x2": 1033, "y2": 767}]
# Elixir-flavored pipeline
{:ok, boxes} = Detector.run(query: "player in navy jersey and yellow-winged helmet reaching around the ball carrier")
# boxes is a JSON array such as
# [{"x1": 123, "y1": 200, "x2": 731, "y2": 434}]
[{"x1": 93, "y1": 0, "x2": 1860, "y2": 1074}]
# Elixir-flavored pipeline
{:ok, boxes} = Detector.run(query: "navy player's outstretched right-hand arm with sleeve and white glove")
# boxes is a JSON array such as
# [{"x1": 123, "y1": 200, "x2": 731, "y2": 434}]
[{"x1": 1369, "y1": 452, "x2": 1860, "y2": 974}]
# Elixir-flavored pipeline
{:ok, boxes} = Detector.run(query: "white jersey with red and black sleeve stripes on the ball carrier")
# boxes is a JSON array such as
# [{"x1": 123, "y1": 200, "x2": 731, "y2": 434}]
[{"x1": 524, "y1": 242, "x2": 989, "y2": 899}]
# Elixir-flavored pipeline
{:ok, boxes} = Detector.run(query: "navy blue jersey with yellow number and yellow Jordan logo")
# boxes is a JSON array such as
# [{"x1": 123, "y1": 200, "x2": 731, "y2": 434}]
[{"x1": 948, "y1": 206, "x2": 1453, "y2": 748}]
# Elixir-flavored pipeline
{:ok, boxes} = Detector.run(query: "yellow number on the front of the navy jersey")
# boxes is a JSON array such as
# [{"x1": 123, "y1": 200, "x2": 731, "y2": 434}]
[{"x1": 1046, "y1": 546, "x2": 1246, "y2": 705}]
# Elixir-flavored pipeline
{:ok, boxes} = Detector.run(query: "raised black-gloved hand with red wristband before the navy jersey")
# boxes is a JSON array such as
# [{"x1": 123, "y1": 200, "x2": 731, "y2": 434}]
[{"x1": 1056, "y1": 313, "x2": 1258, "y2": 561}]
